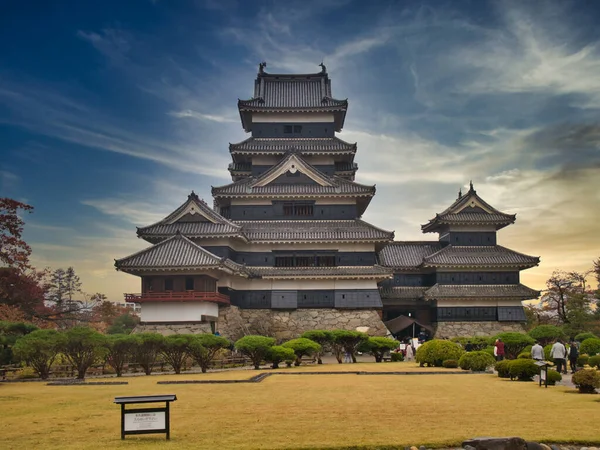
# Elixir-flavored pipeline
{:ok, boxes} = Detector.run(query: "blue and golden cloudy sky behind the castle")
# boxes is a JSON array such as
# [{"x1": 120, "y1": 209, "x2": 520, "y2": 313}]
[{"x1": 0, "y1": 0, "x2": 600, "y2": 301}]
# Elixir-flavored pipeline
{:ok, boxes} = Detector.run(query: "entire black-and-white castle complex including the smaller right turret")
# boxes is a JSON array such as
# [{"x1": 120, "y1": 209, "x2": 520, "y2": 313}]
[{"x1": 115, "y1": 63, "x2": 539, "y2": 338}]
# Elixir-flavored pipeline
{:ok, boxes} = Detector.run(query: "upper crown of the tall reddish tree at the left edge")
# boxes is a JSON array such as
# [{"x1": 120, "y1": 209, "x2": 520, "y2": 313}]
[{"x1": 0, "y1": 197, "x2": 33, "y2": 271}]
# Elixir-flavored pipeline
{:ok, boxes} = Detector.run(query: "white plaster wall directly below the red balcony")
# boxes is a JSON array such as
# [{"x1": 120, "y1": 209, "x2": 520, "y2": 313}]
[{"x1": 141, "y1": 302, "x2": 219, "y2": 322}]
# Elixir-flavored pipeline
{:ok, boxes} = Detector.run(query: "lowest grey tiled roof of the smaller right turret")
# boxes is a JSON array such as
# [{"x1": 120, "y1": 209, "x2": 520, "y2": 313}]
[{"x1": 425, "y1": 284, "x2": 540, "y2": 300}]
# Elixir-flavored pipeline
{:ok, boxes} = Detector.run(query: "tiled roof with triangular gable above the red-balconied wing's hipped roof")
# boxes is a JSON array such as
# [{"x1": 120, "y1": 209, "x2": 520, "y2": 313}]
[{"x1": 137, "y1": 192, "x2": 241, "y2": 240}]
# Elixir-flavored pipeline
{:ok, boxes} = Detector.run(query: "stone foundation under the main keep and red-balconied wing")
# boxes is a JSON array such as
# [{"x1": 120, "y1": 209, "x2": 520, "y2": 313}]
[{"x1": 133, "y1": 306, "x2": 389, "y2": 341}]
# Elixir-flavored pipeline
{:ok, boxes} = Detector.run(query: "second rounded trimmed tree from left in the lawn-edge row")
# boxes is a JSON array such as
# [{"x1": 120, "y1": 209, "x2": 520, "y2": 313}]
[{"x1": 61, "y1": 327, "x2": 107, "y2": 380}]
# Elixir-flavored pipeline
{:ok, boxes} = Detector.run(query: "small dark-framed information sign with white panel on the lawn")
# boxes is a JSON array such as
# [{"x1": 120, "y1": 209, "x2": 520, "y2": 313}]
[{"x1": 114, "y1": 395, "x2": 177, "y2": 439}]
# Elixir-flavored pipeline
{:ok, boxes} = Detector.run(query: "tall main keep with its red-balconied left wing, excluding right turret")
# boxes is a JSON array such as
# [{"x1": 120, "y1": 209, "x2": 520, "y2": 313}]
[{"x1": 115, "y1": 63, "x2": 394, "y2": 338}]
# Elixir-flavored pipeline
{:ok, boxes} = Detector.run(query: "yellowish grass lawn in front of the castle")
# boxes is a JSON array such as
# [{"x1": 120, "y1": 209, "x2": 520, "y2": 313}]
[{"x1": 0, "y1": 363, "x2": 600, "y2": 450}]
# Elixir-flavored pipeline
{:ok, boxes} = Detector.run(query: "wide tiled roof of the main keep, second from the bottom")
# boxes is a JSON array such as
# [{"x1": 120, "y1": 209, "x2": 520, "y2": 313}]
[{"x1": 236, "y1": 219, "x2": 394, "y2": 242}]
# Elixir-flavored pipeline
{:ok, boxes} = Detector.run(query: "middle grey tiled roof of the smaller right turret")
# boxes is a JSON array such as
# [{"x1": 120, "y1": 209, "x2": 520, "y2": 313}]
[{"x1": 423, "y1": 245, "x2": 540, "y2": 267}]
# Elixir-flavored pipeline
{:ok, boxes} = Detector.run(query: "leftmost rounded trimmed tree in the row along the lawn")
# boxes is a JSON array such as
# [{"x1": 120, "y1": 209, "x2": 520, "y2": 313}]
[{"x1": 13, "y1": 330, "x2": 61, "y2": 380}]
